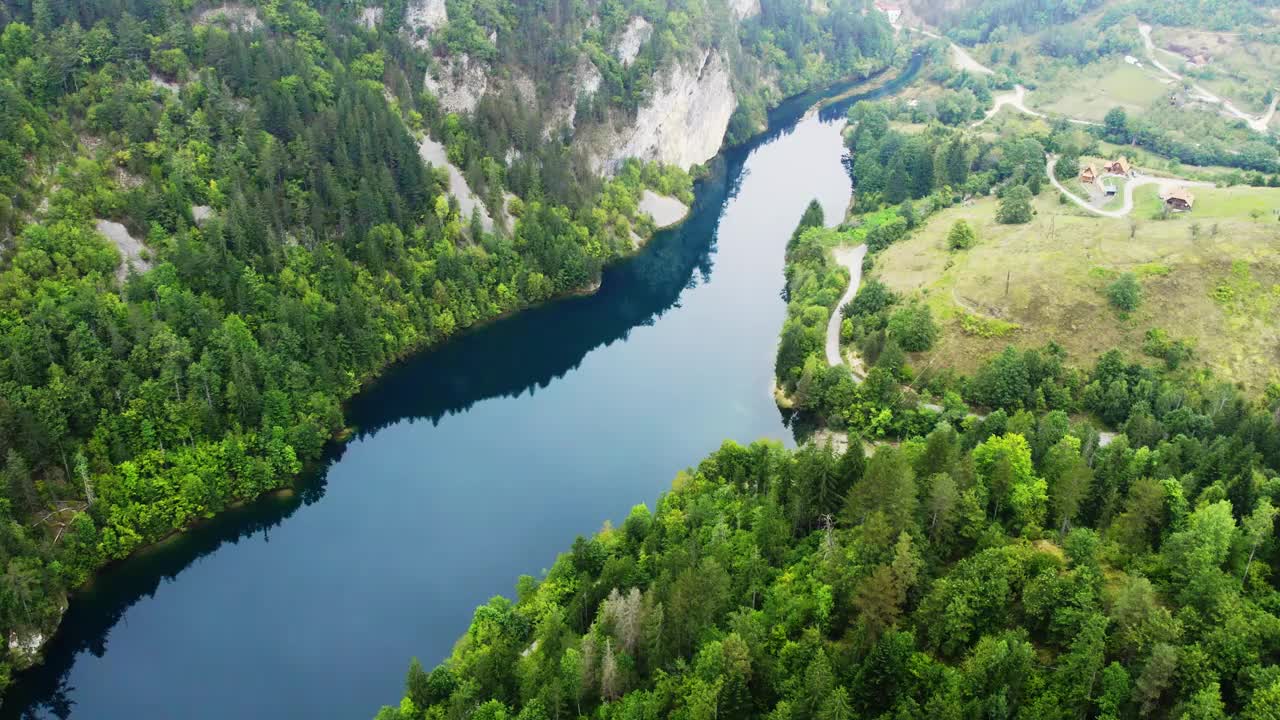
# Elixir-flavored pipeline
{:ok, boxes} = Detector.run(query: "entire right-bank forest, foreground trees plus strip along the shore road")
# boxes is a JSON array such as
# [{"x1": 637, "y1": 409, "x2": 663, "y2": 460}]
[{"x1": 378, "y1": 79, "x2": 1280, "y2": 720}]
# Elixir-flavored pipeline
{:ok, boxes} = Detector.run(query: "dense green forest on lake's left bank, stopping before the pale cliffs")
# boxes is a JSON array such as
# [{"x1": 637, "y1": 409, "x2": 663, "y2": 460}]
[{"x1": 0, "y1": 3, "x2": 650, "y2": 681}]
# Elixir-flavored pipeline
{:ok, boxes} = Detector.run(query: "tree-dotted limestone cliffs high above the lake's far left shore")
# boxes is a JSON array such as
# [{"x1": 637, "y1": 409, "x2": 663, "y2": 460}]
[{"x1": 417, "y1": 0, "x2": 860, "y2": 174}]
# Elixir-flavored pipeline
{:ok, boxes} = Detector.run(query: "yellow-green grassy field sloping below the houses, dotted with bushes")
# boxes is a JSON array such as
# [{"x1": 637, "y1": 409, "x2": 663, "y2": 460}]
[{"x1": 876, "y1": 188, "x2": 1280, "y2": 389}]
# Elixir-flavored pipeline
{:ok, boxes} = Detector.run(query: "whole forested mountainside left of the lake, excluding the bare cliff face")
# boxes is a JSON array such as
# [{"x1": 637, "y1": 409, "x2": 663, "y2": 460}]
[{"x1": 0, "y1": 0, "x2": 893, "y2": 685}]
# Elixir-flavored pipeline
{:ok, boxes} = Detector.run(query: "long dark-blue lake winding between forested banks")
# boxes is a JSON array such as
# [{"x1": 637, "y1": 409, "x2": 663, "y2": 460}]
[{"x1": 0, "y1": 58, "x2": 919, "y2": 720}]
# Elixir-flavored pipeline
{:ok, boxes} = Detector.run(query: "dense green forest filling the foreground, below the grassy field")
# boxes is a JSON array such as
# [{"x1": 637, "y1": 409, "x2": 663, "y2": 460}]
[{"x1": 378, "y1": 351, "x2": 1280, "y2": 720}]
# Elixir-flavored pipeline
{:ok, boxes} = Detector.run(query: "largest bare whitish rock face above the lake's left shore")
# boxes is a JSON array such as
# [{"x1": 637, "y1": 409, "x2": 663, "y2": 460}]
[{"x1": 594, "y1": 50, "x2": 737, "y2": 173}]
